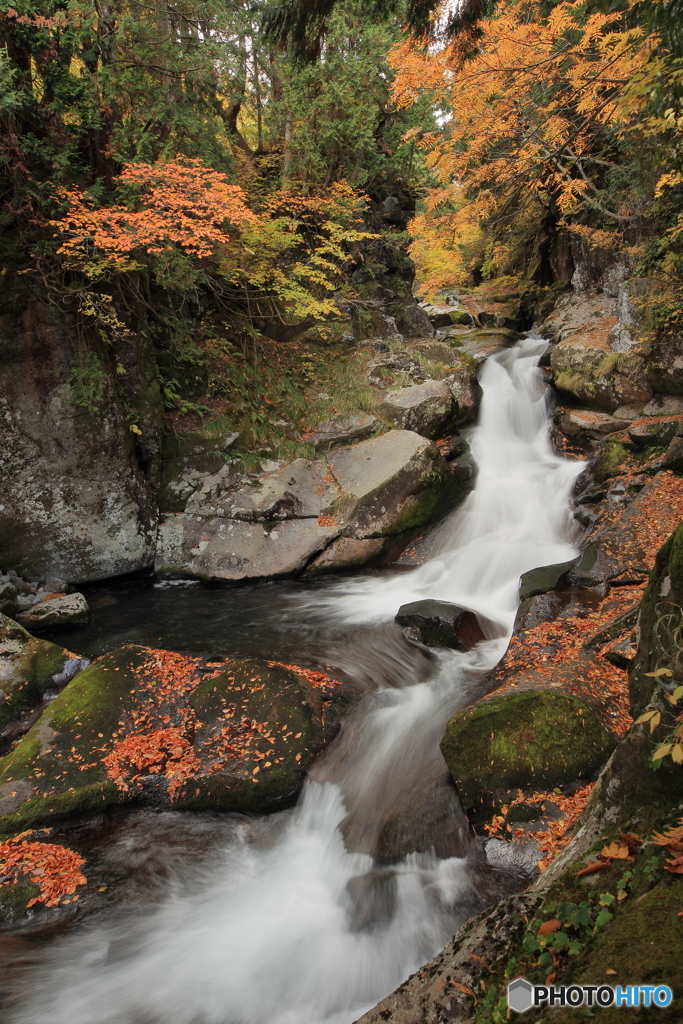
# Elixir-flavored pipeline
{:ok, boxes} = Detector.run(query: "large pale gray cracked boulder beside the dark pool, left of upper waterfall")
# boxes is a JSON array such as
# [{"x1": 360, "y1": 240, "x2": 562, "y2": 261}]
[{"x1": 156, "y1": 430, "x2": 449, "y2": 580}]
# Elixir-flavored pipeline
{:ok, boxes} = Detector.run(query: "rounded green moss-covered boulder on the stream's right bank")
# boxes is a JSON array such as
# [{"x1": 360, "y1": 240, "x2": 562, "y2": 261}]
[{"x1": 441, "y1": 690, "x2": 615, "y2": 810}]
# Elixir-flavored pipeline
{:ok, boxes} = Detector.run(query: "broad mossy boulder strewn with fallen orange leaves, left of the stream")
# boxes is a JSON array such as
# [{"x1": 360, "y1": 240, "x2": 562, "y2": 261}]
[{"x1": 0, "y1": 645, "x2": 344, "y2": 835}]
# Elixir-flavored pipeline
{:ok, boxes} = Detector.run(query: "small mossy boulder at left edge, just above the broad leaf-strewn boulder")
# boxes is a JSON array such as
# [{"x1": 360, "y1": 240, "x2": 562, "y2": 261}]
[{"x1": 0, "y1": 615, "x2": 86, "y2": 731}]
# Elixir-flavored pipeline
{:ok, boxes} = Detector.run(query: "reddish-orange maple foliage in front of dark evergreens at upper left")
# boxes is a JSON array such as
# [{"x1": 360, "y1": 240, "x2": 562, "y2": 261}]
[{"x1": 52, "y1": 158, "x2": 259, "y2": 263}]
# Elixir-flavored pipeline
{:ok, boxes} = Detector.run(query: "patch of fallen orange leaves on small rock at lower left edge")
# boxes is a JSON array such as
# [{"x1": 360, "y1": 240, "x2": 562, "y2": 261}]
[{"x1": 0, "y1": 833, "x2": 87, "y2": 906}]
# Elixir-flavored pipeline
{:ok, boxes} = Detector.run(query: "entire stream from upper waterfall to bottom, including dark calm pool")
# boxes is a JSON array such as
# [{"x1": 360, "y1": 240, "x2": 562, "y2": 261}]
[{"x1": 10, "y1": 338, "x2": 583, "y2": 1024}]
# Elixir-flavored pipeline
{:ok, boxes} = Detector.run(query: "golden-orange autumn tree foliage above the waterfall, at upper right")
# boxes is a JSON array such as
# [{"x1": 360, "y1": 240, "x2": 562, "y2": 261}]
[{"x1": 391, "y1": 0, "x2": 654, "y2": 289}]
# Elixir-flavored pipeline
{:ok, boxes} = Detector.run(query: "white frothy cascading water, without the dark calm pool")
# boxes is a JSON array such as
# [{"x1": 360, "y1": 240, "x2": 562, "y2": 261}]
[{"x1": 12, "y1": 339, "x2": 582, "y2": 1024}]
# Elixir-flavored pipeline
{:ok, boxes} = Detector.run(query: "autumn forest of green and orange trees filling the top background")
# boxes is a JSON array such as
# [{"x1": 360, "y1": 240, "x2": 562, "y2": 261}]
[{"x1": 0, "y1": 0, "x2": 683, "y2": 458}]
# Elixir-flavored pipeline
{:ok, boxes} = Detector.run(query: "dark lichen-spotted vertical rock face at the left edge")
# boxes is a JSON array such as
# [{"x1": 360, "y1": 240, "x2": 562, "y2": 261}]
[{"x1": 0, "y1": 292, "x2": 157, "y2": 583}]
